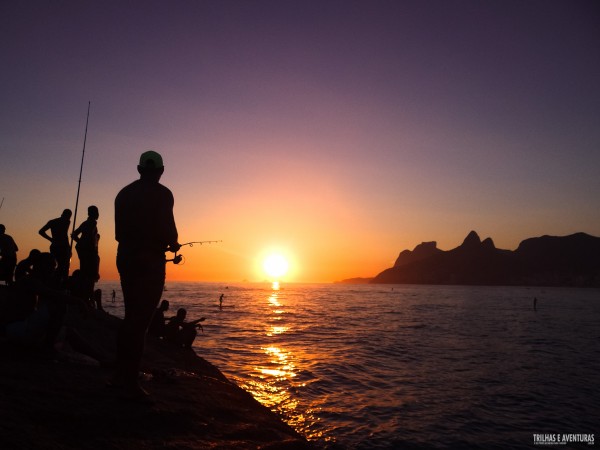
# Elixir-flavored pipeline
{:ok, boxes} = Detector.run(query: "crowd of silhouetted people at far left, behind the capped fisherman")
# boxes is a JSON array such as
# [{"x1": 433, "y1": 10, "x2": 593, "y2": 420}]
[{"x1": 0, "y1": 206, "x2": 102, "y2": 353}]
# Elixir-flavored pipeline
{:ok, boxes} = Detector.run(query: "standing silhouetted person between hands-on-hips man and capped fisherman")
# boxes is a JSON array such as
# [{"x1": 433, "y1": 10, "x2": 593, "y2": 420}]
[{"x1": 71, "y1": 205, "x2": 100, "y2": 297}]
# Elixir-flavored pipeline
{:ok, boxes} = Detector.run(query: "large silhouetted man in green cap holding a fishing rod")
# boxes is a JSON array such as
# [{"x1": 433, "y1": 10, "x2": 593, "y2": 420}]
[{"x1": 109, "y1": 150, "x2": 181, "y2": 400}]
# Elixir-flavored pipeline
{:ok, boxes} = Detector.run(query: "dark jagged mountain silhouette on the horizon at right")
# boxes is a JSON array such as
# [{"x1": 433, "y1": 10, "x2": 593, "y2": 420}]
[{"x1": 371, "y1": 231, "x2": 600, "y2": 287}]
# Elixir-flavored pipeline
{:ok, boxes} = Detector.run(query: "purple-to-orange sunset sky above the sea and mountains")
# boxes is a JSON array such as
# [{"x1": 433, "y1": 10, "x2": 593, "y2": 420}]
[{"x1": 0, "y1": 0, "x2": 600, "y2": 282}]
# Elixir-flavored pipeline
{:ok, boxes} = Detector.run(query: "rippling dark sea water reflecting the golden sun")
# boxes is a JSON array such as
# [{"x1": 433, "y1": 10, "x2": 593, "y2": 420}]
[{"x1": 96, "y1": 283, "x2": 600, "y2": 449}]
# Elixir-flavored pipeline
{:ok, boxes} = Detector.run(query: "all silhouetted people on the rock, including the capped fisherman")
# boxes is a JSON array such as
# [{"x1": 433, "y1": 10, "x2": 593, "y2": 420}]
[{"x1": 0, "y1": 150, "x2": 199, "y2": 401}]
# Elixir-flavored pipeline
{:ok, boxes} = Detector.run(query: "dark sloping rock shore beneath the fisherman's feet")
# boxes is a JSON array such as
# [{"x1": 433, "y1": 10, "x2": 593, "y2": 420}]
[{"x1": 0, "y1": 311, "x2": 314, "y2": 450}]
